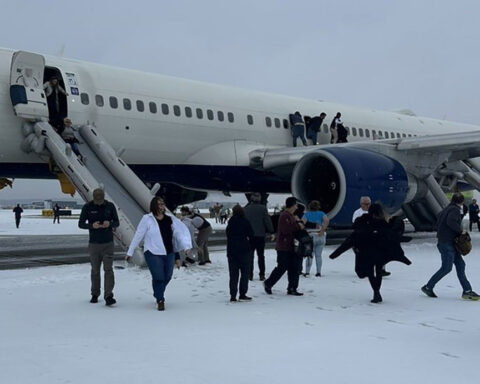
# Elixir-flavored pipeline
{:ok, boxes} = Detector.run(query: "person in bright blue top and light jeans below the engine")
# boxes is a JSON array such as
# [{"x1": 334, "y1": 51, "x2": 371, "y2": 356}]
[{"x1": 303, "y1": 200, "x2": 329, "y2": 277}]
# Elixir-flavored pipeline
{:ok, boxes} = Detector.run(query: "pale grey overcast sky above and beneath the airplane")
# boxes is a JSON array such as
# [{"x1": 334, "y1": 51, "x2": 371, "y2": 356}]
[{"x1": 0, "y1": 0, "x2": 480, "y2": 199}]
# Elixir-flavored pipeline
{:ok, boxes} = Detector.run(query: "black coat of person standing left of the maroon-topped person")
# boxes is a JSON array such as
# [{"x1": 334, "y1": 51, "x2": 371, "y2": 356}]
[{"x1": 226, "y1": 216, "x2": 254, "y2": 260}]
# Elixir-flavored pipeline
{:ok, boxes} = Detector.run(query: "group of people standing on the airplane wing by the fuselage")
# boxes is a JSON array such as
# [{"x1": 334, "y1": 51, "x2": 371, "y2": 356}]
[{"x1": 289, "y1": 111, "x2": 348, "y2": 147}]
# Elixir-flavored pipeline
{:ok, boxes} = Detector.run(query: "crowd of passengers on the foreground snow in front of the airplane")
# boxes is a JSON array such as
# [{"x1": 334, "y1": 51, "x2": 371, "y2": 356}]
[{"x1": 72, "y1": 189, "x2": 480, "y2": 311}]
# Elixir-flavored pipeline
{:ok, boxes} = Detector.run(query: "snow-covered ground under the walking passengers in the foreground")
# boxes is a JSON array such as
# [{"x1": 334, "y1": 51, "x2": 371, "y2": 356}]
[{"x1": 0, "y1": 219, "x2": 480, "y2": 384}]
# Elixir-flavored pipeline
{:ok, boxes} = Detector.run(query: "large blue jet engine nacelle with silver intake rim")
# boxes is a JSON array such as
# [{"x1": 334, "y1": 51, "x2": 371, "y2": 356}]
[{"x1": 292, "y1": 147, "x2": 409, "y2": 226}]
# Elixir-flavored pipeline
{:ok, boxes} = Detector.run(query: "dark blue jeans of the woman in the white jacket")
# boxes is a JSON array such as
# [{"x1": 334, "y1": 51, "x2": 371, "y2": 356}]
[{"x1": 144, "y1": 251, "x2": 175, "y2": 302}]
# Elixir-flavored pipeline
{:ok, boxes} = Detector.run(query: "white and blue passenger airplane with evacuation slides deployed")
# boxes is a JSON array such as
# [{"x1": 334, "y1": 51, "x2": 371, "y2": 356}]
[{"x1": 0, "y1": 48, "x2": 480, "y2": 230}]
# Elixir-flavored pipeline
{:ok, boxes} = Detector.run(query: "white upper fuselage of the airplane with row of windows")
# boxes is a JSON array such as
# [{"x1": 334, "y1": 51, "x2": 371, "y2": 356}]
[{"x1": 0, "y1": 49, "x2": 480, "y2": 192}]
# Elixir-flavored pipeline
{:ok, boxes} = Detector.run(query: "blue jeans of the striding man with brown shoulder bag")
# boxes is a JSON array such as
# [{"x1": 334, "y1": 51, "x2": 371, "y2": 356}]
[{"x1": 427, "y1": 243, "x2": 472, "y2": 292}]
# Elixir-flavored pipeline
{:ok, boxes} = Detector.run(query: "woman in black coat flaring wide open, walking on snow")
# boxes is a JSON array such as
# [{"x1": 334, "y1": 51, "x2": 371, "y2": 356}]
[{"x1": 330, "y1": 204, "x2": 411, "y2": 303}]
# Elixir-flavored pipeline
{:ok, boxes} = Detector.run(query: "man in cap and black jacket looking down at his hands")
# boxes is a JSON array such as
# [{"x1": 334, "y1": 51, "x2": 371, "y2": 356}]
[{"x1": 78, "y1": 188, "x2": 120, "y2": 306}]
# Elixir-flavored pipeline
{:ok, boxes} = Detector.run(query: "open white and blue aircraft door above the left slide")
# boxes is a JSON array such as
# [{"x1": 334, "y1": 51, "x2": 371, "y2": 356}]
[{"x1": 10, "y1": 51, "x2": 48, "y2": 119}]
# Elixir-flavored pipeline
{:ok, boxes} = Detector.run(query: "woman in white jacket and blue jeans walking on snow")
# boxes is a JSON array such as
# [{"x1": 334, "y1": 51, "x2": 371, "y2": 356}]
[{"x1": 127, "y1": 197, "x2": 192, "y2": 311}]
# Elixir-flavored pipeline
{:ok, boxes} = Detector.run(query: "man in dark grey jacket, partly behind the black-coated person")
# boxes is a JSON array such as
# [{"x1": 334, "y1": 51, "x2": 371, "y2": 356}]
[{"x1": 244, "y1": 192, "x2": 274, "y2": 281}]
